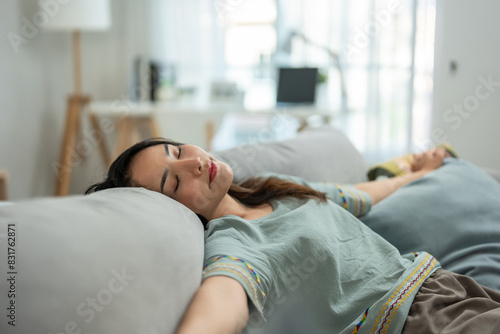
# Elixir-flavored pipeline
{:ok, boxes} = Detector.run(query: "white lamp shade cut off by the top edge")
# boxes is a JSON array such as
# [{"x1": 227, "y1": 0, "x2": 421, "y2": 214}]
[{"x1": 38, "y1": 0, "x2": 111, "y2": 30}]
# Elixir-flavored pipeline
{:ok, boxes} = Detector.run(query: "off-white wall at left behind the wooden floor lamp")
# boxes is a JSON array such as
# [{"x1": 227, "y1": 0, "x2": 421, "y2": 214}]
[{"x1": 0, "y1": 0, "x2": 149, "y2": 200}]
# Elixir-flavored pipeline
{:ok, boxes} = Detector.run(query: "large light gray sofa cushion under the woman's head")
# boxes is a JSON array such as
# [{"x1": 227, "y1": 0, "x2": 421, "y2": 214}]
[{"x1": 0, "y1": 188, "x2": 203, "y2": 334}]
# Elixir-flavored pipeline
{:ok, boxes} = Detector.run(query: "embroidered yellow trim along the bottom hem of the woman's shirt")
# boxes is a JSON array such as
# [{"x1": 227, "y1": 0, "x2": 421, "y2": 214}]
[{"x1": 371, "y1": 254, "x2": 437, "y2": 333}]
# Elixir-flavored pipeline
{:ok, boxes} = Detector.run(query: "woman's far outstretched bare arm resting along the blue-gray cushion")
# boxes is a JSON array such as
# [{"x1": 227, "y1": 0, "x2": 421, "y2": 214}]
[{"x1": 355, "y1": 147, "x2": 446, "y2": 205}]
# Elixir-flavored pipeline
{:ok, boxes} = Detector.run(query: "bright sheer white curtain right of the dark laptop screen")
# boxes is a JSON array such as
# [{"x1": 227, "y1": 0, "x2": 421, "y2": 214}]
[{"x1": 277, "y1": 0, "x2": 435, "y2": 162}]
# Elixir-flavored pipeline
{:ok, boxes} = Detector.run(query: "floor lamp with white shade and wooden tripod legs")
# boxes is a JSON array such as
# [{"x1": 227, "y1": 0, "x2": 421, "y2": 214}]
[{"x1": 39, "y1": 0, "x2": 111, "y2": 196}]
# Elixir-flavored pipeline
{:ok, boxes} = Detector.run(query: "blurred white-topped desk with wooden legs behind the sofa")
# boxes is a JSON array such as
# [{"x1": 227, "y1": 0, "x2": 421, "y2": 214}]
[{"x1": 89, "y1": 100, "x2": 337, "y2": 163}]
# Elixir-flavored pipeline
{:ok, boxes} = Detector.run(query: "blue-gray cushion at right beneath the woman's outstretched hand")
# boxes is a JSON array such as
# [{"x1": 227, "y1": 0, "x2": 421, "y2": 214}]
[{"x1": 361, "y1": 159, "x2": 500, "y2": 291}]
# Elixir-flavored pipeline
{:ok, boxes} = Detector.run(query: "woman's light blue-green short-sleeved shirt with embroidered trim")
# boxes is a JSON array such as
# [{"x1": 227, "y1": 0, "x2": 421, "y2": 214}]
[{"x1": 203, "y1": 176, "x2": 439, "y2": 333}]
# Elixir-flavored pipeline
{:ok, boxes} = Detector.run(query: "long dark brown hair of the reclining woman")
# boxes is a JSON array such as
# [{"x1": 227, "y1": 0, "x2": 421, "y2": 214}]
[{"x1": 85, "y1": 138, "x2": 326, "y2": 224}]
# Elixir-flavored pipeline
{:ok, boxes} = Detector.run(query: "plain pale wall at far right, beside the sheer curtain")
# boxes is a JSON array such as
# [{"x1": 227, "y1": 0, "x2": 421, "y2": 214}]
[{"x1": 432, "y1": 0, "x2": 500, "y2": 170}]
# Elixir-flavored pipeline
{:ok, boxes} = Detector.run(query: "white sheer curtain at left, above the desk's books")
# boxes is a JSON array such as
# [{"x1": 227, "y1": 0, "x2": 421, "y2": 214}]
[{"x1": 149, "y1": 0, "x2": 225, "y2": 98}]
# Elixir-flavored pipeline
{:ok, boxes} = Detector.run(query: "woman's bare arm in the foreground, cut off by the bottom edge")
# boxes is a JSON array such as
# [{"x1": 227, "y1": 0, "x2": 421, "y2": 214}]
[{"x1": 177, "y1": 276, "x2": 249, "y2": 334}]
